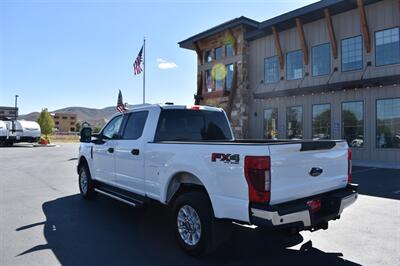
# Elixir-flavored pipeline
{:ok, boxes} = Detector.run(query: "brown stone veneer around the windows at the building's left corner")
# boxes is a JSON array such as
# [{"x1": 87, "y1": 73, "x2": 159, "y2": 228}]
[{"x1": 197, "y1": 26, "x2": 250, "y2": 139}]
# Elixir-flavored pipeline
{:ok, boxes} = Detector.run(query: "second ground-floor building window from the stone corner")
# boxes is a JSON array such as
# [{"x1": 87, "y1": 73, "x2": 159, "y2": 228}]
[{"x1": 286, "y1": 106, "x2": 303, "y2": 139}]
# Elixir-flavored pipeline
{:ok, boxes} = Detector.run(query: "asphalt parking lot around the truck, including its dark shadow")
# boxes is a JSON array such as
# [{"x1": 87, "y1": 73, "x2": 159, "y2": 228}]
[{"x1": 0, "y1": 144, "x2": 400, "y2": 265}]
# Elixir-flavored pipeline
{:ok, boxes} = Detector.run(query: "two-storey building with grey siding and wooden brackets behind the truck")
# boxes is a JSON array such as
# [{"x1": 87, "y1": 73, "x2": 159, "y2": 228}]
[{"x1": 180, "y1": 0, "x2": 400, "y2": 167}]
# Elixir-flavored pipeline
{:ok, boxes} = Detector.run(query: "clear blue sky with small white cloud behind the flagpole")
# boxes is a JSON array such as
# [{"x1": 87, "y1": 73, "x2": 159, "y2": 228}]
[{"x1": 0, "y1": 0, "x2": 315, "y2": 114}]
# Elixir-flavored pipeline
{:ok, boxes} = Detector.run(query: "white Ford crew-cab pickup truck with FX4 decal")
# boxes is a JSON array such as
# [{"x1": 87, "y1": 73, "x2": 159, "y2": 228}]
[{"x1": 77, "y1": 104, "x2": 357, "y2": 255}]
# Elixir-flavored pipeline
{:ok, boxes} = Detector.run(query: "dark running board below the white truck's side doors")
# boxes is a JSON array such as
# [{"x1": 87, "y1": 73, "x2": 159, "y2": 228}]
[{"x1": 94, "y1": 182, "x2": 145, "y2": 208}]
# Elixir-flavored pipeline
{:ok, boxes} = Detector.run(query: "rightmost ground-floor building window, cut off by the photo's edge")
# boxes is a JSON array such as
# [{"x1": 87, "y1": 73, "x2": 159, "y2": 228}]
[{"x1": 376, "y1": 98, "x2": 400, "y2": 149}]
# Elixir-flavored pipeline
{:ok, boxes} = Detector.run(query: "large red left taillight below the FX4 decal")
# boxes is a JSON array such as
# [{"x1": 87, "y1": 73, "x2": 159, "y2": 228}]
[{"x1": 244, "y1": 156, "x2": 271, "y2": 203}]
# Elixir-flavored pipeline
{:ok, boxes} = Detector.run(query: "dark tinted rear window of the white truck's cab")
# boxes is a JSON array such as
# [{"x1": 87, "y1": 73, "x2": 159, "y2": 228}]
[{"x1": 155, "y1": 109, "x2": 232, "y2": 141}]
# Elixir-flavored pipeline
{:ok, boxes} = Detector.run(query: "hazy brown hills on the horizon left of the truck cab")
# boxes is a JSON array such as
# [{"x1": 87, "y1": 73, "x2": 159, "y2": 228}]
[{"x1": 18, "y1": 105, "x2": 135, "y2": 125}]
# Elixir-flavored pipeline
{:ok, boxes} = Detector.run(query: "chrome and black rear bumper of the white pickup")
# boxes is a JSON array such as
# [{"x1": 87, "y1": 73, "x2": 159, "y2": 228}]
[{"x1": 250, "y1": 184, "x2": 358, "y2": 230}]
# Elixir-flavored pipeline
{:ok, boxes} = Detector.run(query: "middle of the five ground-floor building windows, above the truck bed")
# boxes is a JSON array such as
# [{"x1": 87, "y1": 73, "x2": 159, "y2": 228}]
[{"x1": 312, "y1": 104, "x2": 331, "y2": 139}]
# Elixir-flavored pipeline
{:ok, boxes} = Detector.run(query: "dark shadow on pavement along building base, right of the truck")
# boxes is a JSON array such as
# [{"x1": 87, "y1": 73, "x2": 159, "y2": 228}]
[{"x1": 353, "y1": 166, "x2": 400, "y2": 200}]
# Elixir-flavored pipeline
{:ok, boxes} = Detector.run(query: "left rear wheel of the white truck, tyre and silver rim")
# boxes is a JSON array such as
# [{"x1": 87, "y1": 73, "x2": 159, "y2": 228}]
[{"x1": 173, "y1": 191, "x2": 215, "y2": 256}]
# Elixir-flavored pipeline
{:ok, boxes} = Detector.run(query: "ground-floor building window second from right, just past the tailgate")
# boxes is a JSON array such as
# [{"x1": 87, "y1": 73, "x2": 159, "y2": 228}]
[{"x1": 342, "y1": 101, "x2": 364, "y2": 148}]
